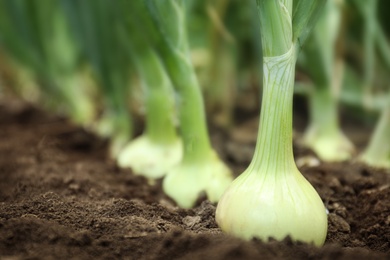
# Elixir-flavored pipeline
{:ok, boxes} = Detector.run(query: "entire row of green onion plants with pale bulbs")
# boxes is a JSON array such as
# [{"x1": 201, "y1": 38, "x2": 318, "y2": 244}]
[{"x1": 0, "y1": 0, "x2": 390, "y2": 249}]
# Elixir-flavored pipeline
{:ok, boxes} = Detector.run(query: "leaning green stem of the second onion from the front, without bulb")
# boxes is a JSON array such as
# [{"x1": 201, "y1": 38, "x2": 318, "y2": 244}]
[{"x1": 142, "y1": 0, "x2": 213, "y2": 164}]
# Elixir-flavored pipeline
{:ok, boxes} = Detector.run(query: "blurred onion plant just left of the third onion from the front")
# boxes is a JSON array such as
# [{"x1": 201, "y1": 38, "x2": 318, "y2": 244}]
[{"x1": 62, "y1": 0, "x2": 133, "y2": 158}]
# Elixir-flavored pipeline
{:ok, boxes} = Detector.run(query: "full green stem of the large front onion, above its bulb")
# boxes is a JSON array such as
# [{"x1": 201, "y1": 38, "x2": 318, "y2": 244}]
[{"x1": 253, "y1": 0, "x2": 297, "y2": 174}]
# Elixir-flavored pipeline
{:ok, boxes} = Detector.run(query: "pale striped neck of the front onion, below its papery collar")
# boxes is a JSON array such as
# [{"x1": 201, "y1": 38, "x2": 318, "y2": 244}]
[{"x1": 249, "y1": 45, "x2": 296, "y2": 173}]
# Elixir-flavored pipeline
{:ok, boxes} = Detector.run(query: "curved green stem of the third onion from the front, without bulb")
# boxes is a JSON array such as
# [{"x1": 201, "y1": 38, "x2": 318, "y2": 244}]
[{"x1": 122, "y1": 9, "x2": 177, "y2": 144}]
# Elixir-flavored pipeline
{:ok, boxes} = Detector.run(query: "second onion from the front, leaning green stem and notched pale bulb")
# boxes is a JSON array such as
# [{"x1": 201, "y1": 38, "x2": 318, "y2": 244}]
[{"x1": 138, "y1": 0, "x2": 232, "y2": 208}]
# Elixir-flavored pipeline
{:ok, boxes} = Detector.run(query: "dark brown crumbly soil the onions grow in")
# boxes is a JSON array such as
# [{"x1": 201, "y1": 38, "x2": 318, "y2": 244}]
[{"x1": 0, "y1": 98, "x2": 390, "y2": 259}]
